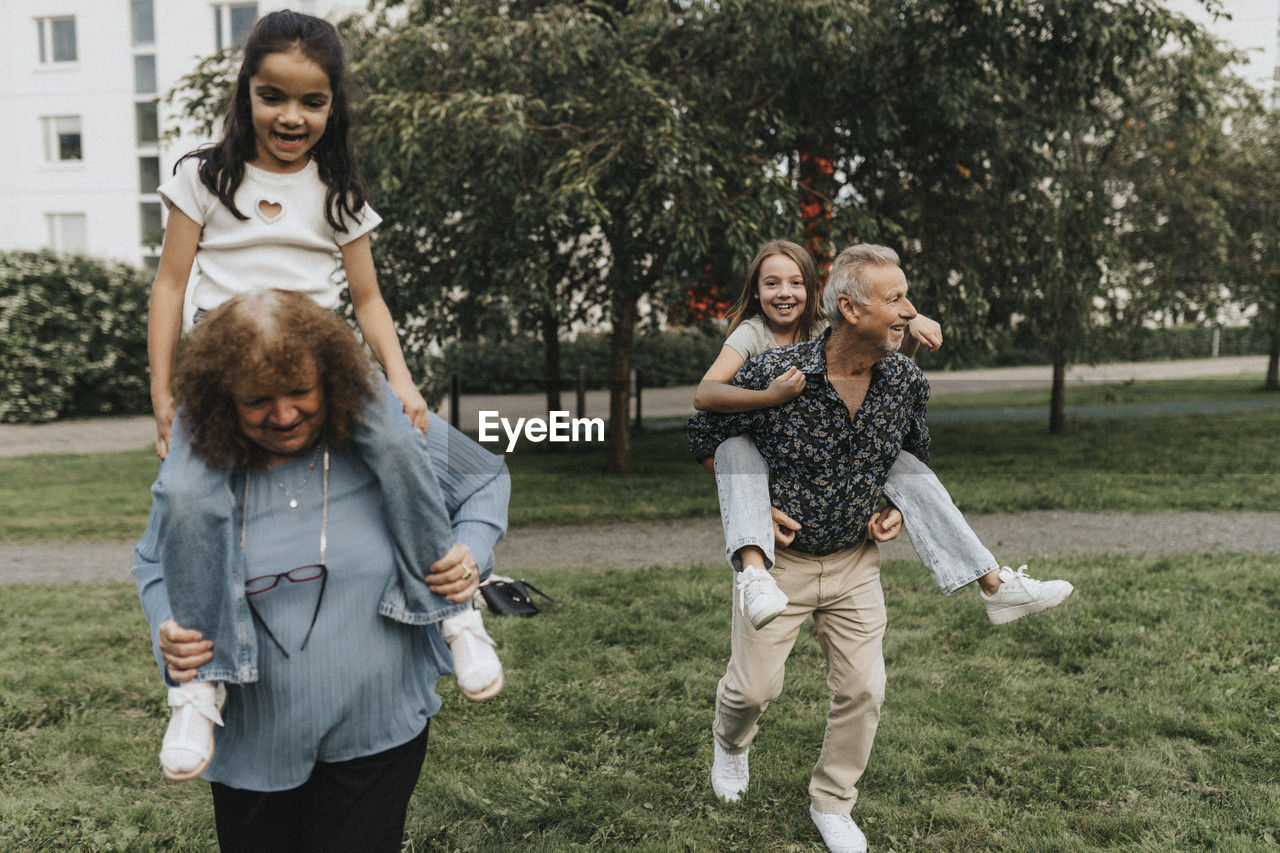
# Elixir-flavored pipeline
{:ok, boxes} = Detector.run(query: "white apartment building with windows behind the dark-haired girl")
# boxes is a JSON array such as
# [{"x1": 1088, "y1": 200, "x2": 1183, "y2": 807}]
[{"x1": 0, "y1": 0, "x2": 365, "y2": 268}]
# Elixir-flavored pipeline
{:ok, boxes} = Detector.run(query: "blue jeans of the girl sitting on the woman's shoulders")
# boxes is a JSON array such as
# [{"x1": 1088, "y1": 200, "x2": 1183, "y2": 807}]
[{"x1": 151, "y1": 377, "x2": 460, "y2": 684}]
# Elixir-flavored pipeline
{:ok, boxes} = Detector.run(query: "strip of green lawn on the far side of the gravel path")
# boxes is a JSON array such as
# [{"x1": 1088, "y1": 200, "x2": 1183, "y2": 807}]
[{"x1": 0, "y1": 378, "x2": 1280, "y2": 540}]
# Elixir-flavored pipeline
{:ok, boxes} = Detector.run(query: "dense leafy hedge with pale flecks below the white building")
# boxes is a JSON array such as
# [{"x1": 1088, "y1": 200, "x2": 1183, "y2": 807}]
[{"x1": 0, "y1": 252, "x2": 151, "y2": 423}]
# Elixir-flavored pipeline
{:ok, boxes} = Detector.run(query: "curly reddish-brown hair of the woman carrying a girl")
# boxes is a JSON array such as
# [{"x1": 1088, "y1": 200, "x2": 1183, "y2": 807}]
[{"x1": 173, "y1": 289, "x2": 375, "y2": 467}]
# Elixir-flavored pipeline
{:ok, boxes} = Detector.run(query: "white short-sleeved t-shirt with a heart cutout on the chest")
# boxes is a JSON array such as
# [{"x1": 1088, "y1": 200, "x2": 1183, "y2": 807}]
[{"x1": 159, "y1": 158, "x2": 381, "y2": 311}]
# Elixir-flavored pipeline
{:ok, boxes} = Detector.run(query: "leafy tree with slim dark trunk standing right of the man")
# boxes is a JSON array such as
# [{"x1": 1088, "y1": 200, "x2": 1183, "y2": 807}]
[{"x1": 861, "y1": 0, "x2": 1233, "y2": 432}]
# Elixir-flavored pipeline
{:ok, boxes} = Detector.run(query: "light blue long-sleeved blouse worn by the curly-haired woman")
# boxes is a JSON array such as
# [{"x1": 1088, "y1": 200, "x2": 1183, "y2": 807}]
[{"x1": 134, "y1": 419, "x2": 509, "y2": 790}]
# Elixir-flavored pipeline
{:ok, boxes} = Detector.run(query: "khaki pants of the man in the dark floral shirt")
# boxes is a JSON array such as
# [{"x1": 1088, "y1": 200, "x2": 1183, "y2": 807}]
[{"x1": 713, "y1": 540, "x2": 886, "y2": 815}]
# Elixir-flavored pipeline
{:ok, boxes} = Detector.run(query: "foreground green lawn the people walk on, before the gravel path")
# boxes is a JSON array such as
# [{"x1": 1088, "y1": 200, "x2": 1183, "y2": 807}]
[{"x1": 0, "y1": 555, "x2": 1280, "y2": 853}]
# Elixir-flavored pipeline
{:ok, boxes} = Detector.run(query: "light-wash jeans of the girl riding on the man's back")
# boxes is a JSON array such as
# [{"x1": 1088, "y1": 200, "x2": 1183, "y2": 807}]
[{"x1": 716, "y1": 435, "x2": 1000, "y2": 596}]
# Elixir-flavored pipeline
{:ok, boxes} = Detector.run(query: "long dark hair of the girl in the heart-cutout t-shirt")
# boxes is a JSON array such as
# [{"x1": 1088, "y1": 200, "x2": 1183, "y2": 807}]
[{"x1": 174, "y1": 9, "x2": 369, "y2": 231}]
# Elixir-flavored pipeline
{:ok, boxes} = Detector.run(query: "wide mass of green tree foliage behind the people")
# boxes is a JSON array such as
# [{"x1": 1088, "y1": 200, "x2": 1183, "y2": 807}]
[{"x1": 160, "y1": 0, "x2": 1280, "y2": 445}]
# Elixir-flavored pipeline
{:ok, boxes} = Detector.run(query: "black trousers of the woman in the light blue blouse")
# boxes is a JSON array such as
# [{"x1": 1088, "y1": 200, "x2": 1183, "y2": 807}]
[{"x1": 212, "y1": 721, "x2": 430, "y2": 853}]
